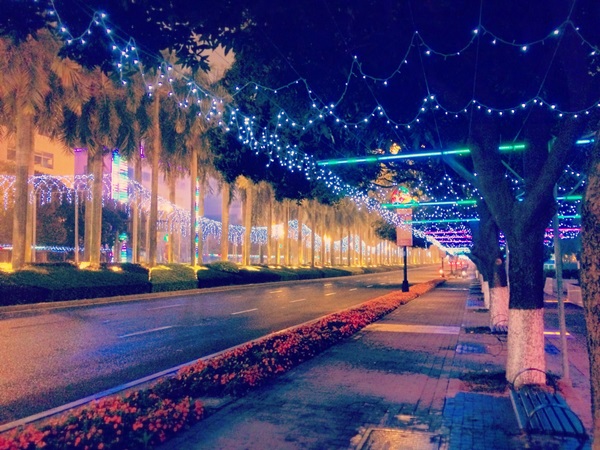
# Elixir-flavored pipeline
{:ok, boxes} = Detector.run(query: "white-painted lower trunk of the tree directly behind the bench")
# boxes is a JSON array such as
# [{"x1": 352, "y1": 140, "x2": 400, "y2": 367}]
[{"x1": 506, "y1": 308, "x2": 546, "y2": 387}]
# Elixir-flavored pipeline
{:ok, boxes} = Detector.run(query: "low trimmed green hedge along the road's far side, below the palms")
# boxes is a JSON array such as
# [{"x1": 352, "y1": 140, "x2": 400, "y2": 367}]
[{"x1": 0, "y1": 261, "x2": 406, "y2": 306}]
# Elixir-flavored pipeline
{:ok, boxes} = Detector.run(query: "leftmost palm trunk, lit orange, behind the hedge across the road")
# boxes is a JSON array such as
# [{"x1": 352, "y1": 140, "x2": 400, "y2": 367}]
[{"x1": 12, "y1": 108, "x2": 34, "y2": 270}]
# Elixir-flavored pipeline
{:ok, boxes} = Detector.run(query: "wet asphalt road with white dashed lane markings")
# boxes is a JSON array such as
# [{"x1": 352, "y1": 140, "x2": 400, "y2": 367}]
[{"x1": 0, "y1": 265, "x2": 438, "y2": 424}]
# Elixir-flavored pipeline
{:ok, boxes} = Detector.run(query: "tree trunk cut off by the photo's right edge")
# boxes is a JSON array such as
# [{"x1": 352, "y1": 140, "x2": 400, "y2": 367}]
[{"x1": 580, "y1": 142, "x2": 600, "y2": 442}]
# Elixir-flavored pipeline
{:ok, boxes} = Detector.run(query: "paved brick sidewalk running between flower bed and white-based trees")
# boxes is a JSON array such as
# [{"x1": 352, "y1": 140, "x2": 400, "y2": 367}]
[{"x1": 163, "y1": 280, "x2": 591, "y2": 450}]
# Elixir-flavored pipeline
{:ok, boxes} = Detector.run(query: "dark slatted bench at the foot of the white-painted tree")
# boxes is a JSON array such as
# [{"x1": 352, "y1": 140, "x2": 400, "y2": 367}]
[{"x1": 510, "y1": 369, "x2": 588, "y2": 442}]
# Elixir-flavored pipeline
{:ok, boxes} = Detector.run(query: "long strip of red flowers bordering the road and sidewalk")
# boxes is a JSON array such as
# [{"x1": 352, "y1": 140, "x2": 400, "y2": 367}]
[{"x1": 0, "y1": 280, "x2": 442, "y2": 450}]
